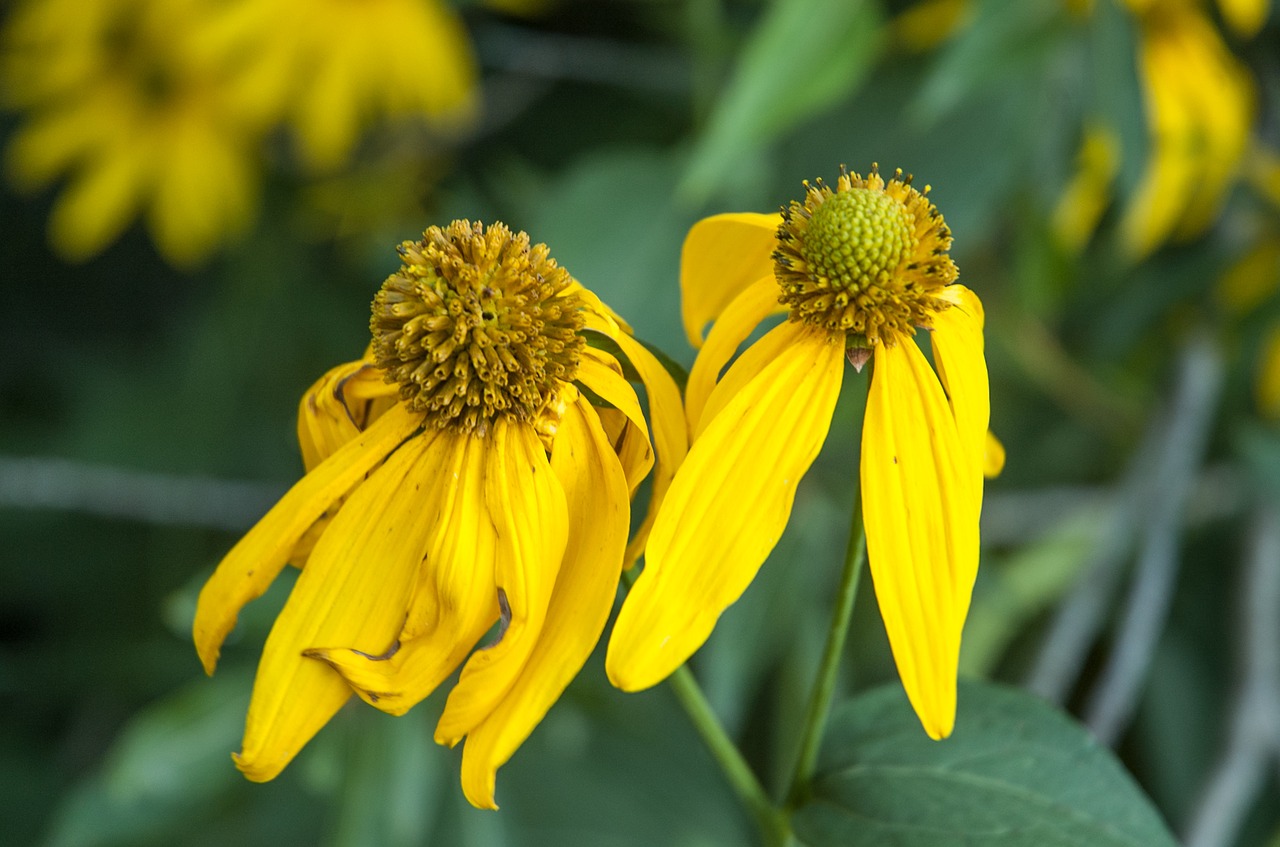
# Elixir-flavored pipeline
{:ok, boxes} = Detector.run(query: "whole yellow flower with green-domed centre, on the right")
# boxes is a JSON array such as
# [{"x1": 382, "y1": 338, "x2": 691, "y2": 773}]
[{"x1": 605, "y1": 166, "x2": 1000, "y2": 738}]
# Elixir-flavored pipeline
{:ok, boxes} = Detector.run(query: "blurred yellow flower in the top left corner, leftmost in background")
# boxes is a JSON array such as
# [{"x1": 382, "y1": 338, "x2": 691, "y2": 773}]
[{"x1": 3, "y1": 0, "x2": 260, "y2": 265}]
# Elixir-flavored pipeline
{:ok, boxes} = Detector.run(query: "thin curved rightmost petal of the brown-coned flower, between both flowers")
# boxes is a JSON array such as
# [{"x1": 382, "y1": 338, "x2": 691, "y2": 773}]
[{"x1": 617, "y1": 334, "x2": 689, "y2": 567}]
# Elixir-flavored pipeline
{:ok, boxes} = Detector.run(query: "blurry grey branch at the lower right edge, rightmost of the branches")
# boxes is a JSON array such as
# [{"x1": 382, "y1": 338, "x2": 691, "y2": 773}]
[{"x1": 1187, "y1": 503, "x2": 1280, "y2": 847}]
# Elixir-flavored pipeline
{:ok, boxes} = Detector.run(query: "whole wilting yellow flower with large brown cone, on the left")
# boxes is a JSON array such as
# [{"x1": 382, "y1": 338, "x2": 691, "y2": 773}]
[{"x1": 193, "y1": 221, "x2": 685, "y2": 807}]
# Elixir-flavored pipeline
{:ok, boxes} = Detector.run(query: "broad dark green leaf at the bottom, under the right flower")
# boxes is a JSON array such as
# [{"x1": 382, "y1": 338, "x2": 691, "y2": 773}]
[{"x1": 794, "y1": 681, "x2": 1176, "y2": 847}]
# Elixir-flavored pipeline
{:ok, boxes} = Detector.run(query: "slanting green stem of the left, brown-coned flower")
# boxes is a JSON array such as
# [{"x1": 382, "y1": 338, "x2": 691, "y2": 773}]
[{"x1": 622, "y1": 571, "x2": 791, "y2": 847}]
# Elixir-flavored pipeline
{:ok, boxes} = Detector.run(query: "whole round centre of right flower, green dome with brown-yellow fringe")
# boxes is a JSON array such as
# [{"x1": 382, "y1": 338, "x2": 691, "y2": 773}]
[{"x1": 773, "y1": 165, "x2": 959, "y2": 347}]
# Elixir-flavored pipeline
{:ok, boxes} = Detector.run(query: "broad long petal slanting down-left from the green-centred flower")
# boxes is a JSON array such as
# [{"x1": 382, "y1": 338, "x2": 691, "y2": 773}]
[{"x1": 605, "y1": 325, "x2": 845, "y2": 691}]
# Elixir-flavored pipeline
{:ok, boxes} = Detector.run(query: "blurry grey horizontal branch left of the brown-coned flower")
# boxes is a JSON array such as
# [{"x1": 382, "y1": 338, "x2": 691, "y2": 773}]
[{"x1": 0, "y1": 457, "x2": 284, "y2": 531}]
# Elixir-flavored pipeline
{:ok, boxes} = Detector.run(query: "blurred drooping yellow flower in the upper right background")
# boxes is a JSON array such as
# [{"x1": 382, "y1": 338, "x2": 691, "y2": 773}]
[{"x1": 1120, "y1": 0, "x2": 1257, "y2": 258}]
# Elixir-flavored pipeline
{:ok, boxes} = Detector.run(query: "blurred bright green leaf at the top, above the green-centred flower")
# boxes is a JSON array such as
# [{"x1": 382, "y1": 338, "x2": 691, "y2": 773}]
[{"x1": 680, "y1": 0, "x2": 881, "y2": 202}]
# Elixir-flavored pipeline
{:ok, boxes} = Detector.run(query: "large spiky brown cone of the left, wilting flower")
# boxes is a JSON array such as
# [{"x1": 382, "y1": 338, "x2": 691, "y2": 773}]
[{"x1": 370, "y1": 220, "x2": 585, "y2": 435}]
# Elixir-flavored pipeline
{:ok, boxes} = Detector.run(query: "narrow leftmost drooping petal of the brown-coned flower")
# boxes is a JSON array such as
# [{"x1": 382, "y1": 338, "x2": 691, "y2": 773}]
[{"x1": 192, "y1": 404, "x2": 420, "y2": 673}]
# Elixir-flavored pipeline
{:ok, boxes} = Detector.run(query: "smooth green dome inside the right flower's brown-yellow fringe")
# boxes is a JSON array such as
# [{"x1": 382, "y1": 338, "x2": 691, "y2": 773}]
[{"x1": 800, "y1": 188, "x2": 914, "y2": 292}]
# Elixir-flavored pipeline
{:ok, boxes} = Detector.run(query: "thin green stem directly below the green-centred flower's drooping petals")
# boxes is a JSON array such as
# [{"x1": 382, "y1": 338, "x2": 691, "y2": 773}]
[{"x1": 787, "y1": 490, "x2": 867, "y2": 809}]
